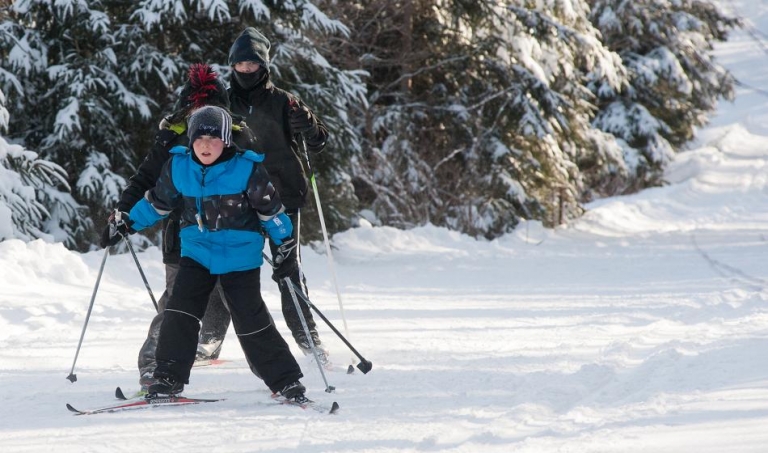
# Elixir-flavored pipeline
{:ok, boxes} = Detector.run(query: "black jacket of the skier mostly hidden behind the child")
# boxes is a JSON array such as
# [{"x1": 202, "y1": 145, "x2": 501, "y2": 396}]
[{"x1": 117, "y1": 116, "x2": 255, "y2": 264}]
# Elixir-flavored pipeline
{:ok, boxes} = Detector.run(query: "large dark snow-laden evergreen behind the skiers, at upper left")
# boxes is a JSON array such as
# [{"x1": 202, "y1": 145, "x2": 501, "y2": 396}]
[{"x1": 0, "y1": 0, "x2": 365, "y2": 248}]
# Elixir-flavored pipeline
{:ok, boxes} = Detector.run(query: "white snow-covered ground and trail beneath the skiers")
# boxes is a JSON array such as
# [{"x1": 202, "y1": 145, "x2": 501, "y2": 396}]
[{"x1": 0, "y1": 1, "x2": 768, "y2": 453}]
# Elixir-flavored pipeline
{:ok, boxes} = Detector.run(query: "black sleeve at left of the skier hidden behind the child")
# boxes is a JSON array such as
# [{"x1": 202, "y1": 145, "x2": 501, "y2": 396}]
[{"x1": 117, "y1": 129, "x2": 179, "y2": 212}]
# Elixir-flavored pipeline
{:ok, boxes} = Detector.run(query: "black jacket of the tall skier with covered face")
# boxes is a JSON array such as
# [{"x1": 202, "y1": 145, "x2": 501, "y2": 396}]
[{"x1": 229, "y1": 74, "x2": 328, "y2": 210}]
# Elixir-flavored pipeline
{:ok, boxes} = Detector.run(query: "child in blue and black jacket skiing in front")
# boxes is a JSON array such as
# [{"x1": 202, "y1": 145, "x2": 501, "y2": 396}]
[{"x1": 106, "y1": 106, "x2": 306, "y2": 402}]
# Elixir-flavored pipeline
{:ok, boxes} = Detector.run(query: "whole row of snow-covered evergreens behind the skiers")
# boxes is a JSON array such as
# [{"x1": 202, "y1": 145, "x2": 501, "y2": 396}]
[{"x1": 0, "y1": 0, "x2": 740, "y2": 250}]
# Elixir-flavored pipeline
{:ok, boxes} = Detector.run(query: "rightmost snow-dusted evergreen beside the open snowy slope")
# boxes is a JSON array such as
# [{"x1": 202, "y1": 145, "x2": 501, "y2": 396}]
[{"x1": 588, "y1": 0, "x2": 739, "y2": 195}]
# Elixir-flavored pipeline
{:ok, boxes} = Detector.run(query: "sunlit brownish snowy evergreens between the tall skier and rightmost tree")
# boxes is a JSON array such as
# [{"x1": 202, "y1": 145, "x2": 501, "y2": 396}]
[{"x1": 324, "y1": 0, "x2": 626, "y2": 233}]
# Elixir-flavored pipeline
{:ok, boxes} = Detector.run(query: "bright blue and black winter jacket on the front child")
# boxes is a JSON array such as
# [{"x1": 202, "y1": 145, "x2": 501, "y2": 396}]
[{"x1": 129, "y1": 146, "x2": 283, "y2": 275}]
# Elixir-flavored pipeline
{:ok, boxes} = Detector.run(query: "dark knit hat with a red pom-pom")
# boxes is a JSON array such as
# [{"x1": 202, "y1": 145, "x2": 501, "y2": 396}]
[{"x1": 173, "y1": 63, "x2": 229, "y2": 116}]
